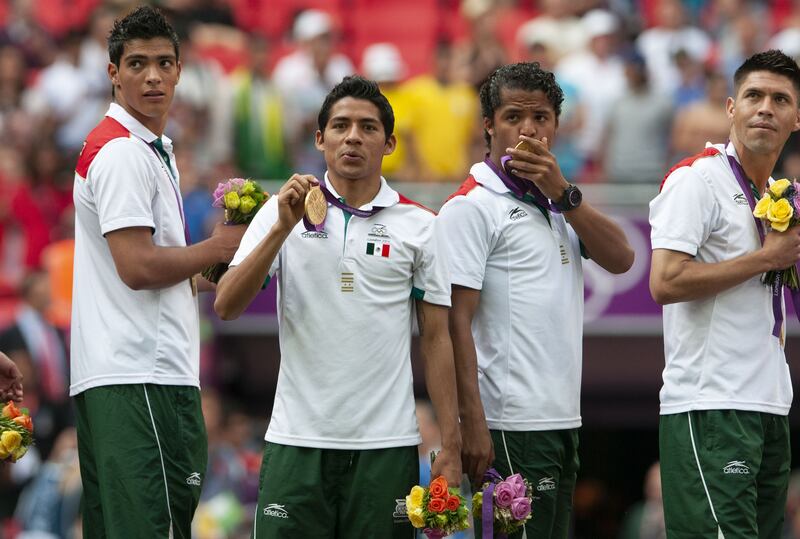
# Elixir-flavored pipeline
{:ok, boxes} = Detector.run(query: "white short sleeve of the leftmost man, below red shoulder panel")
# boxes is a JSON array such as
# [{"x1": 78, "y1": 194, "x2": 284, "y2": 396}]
[{"x1": 87, "y1": 138, "x2": 156, "y2": 236}]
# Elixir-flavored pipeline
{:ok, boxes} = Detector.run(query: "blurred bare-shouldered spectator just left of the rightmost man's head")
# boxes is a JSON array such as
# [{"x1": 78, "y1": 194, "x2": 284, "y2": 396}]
[{"x1": 665, "y1": 72, "x2": 730, "y2": 159}]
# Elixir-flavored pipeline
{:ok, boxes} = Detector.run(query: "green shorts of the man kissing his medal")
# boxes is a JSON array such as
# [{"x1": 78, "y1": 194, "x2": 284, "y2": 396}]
[{"x1": 475, "y1": 429, "x2": 579, "y2": 539}]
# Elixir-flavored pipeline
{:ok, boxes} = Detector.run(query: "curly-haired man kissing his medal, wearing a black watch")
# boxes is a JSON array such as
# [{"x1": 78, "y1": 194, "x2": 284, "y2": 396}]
[{"x1": 437, "y1": 63, "x2": 633, "y2": 538}]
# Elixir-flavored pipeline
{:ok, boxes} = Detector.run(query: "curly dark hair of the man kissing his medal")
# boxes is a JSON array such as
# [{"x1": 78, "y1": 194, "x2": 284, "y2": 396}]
[{"x1": 480, "y1": 62, "x2": 564, "y2": 148}]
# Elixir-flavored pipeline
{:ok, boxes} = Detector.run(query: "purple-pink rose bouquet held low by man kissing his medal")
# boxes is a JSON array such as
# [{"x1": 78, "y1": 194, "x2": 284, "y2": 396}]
[{"x1": 472, "y1": 468, "x2": 533, "y2": 537}]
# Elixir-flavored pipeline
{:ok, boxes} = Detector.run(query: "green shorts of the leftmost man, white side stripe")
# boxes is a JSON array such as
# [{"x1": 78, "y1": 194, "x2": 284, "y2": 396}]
[{"x1": 75, "y1": 384, "x2": 208, "y2": 539}]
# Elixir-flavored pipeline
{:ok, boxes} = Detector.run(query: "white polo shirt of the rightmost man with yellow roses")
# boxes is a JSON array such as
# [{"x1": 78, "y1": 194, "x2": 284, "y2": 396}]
[{"x1": 650, "y1": 144, "x2": 792, "y2": 415}]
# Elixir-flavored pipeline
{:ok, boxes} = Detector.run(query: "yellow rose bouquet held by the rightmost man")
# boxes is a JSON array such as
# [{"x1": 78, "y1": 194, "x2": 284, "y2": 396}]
[{"x1": 753, "y1": 179, "x2": 800, "y2": 290}]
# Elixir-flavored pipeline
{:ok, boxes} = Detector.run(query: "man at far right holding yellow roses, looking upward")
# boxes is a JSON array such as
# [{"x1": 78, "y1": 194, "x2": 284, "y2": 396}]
[{"x1": 650, "y1": 50, "x2": 800, "y2": 539}]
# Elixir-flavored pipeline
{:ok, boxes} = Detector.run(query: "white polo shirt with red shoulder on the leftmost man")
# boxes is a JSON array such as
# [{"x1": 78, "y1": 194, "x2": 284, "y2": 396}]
[{"x1": 70, "y1": 104, "x2": 199, "y2": 395}]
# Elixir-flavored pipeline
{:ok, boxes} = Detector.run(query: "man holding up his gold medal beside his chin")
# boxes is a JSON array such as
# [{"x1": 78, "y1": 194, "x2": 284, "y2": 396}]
[{"x1": 214, "y1": 77, "x2": 461, "y2": 539}]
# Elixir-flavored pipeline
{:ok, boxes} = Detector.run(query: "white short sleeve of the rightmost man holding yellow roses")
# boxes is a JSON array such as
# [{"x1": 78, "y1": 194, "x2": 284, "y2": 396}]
[{"x1": 650, "y1": 167, "x2": 717, "y2": 256}]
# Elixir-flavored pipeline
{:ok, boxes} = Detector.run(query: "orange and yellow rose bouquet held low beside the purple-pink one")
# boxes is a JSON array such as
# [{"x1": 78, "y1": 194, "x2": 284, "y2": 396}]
[{"x1": 406, "y1": 475, "x2": 469, "y2": 539}]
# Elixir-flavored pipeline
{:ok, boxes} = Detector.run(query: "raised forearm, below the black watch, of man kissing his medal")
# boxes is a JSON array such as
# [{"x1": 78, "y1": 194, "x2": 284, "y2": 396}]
[{"x1": 564, "y1": 202, "x2": 634, "y2": 273}]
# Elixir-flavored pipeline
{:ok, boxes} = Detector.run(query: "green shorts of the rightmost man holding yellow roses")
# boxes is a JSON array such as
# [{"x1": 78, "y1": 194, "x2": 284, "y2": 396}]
[{"x1": 659, "y1": 410, "x2": 791, "y2": 539}]
